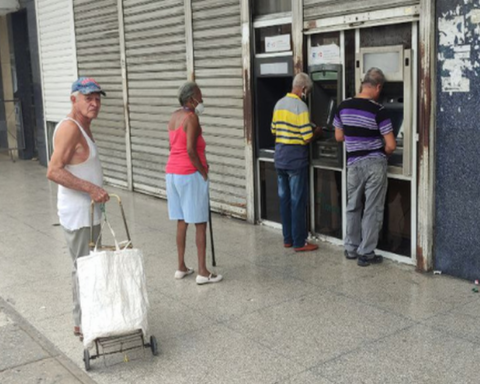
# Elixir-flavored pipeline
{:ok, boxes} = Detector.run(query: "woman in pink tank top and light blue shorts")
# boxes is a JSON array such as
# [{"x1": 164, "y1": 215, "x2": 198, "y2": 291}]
[{"x1": 165, "y1": 82, "x2": 222, "y2": 285}]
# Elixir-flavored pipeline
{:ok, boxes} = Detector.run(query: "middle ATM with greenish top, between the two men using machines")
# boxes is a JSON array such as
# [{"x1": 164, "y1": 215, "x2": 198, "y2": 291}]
[{"x1": 308, "y1": 64, "x2": 344, "y2": 239}]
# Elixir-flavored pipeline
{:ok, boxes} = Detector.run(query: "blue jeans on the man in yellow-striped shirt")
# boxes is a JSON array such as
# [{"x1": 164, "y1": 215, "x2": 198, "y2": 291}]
[{"x1": 277, "y1": 167, "x2": 308, "y2": 248}]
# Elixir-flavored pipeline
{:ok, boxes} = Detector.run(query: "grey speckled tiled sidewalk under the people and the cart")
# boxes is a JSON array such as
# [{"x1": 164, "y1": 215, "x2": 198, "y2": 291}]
[{"x1": 0, "y1": 156, "x2": 480, "y2": 384}]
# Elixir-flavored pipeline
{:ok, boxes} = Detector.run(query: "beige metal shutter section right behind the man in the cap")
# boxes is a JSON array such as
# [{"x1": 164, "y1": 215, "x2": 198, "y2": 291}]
[{"x1": 73, "y1": 0, "x2": 128, "y2": 188}]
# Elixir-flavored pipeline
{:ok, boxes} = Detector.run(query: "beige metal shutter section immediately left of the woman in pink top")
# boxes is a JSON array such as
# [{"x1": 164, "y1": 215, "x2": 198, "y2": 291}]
[{"x1": 123, "y1": 0, "x2": 187, "y2": 196}]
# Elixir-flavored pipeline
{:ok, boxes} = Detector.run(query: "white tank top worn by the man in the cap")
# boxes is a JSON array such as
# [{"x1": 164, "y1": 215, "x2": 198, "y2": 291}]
[{"x1": 53, "y1": 117, "x2": 103, "y2": 231}]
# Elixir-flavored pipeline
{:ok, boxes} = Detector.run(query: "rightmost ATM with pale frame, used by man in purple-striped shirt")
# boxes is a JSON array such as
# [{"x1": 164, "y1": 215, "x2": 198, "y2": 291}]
[{"x1": 355, "y1": 45, "x2": 416, "y2": 256}]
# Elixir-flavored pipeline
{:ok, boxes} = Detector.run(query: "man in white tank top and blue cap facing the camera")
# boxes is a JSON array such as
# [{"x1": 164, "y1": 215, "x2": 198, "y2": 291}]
[{"x1": 47, "y1": 77, "x2": 109, "y2": 336}]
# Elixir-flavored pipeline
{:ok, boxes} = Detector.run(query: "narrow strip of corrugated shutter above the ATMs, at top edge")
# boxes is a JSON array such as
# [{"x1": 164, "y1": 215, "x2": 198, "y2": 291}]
[{"x1": 303, "y1": 0, "x2": 420, "y2": 21}]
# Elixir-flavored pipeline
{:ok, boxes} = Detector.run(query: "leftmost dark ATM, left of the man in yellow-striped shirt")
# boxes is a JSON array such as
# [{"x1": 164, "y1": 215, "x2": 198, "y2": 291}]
[{"x1": 254, "y1": 56, "x2": 293, "y2": 223}]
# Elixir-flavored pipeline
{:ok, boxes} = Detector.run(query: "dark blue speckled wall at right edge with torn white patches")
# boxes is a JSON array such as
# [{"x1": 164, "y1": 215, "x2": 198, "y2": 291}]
[{"x1": 434, "y1": 0, "x2": 480, "y2": 280}]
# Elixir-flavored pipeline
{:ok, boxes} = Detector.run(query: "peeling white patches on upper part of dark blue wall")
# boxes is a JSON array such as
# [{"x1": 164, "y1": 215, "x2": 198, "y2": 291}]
[{"x1": 438, "y1": 4, "x2": 480, "y2": 94}]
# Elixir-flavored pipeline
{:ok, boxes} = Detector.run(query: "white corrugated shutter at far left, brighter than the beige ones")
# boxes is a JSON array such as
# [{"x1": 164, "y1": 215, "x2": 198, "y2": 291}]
[{"x1": 36, "y1": 0, "x2": 77, "y2": 122}]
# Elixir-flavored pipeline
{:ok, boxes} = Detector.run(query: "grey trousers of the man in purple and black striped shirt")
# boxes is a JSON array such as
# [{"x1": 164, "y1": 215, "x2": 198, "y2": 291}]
[{"x1": 345, "y1": 158, "x2": 387, "y2": 257}]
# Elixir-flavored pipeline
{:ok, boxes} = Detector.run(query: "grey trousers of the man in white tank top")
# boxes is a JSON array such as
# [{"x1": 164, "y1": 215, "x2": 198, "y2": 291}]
[{"x1": 63, "y1": 225, "x2": 100, "y2": 327}]
